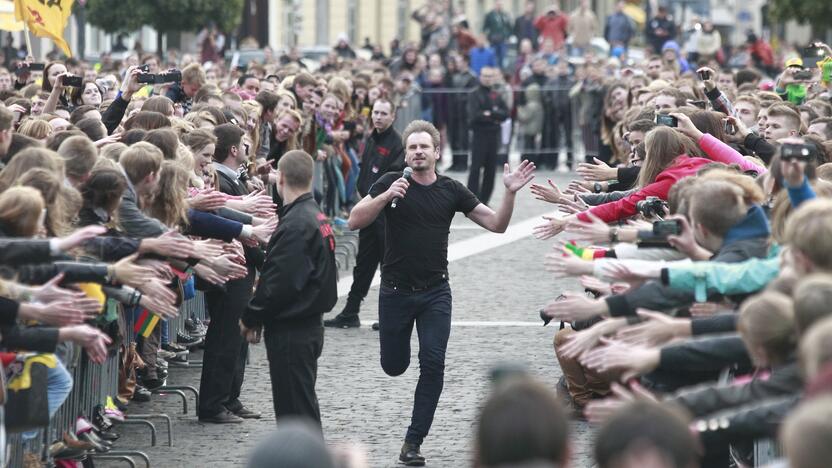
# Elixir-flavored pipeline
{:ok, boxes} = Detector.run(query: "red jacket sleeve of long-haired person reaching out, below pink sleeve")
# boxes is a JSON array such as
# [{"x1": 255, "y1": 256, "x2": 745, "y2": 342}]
[{"x1": 578, "y1": 155, "x2": 713, "y2": 223}]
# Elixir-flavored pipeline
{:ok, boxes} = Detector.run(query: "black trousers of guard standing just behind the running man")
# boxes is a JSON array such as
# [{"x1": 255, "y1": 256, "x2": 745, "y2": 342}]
[{"x1": 341, "y1": 218, "x2": 384, "y2": 316}]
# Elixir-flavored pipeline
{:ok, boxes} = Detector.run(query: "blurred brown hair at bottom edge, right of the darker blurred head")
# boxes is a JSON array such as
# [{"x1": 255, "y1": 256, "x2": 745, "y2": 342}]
[{"x1": 595, "y1": 401, "x2": 699, "y2": 468}]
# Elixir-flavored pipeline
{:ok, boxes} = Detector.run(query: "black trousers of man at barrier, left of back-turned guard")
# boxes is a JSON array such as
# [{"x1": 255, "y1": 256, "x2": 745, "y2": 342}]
[{"x1": 199, "y1": 268, "x2": 255, "y2": 417}]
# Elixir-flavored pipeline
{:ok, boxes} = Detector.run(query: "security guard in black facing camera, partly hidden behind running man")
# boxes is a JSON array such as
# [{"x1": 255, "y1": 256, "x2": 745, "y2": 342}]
[{"x1": 324, "y1": 98, "x2": 405, "y2": 328}]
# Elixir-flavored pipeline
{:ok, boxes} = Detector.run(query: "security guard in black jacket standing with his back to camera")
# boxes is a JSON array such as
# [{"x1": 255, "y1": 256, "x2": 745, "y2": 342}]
[{"x1": 240, "y1": 150, "x2": 338, "y2": 424}]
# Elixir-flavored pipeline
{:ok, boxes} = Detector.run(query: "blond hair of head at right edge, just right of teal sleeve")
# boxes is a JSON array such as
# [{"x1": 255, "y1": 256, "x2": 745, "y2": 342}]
[{"x1": 788, "y1": 199, "x2": 832, "y2": 272}]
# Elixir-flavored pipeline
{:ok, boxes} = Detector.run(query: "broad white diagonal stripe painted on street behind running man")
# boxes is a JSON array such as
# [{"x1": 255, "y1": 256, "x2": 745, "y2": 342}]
[{"x1": 338, "y1": 215, "x2": 542, "y2": 297}]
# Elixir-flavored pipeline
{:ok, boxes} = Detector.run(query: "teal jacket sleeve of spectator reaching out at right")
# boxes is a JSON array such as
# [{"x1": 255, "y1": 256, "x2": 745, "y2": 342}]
[{"x1": 662, "y1": 245, "x2": 780, "y2": 302}]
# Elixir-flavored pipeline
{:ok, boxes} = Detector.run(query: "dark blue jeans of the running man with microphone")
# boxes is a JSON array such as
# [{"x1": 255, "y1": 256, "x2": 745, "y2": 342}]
[{"x1": 378, "y1": 282, "x2": 451, "y2": 444}]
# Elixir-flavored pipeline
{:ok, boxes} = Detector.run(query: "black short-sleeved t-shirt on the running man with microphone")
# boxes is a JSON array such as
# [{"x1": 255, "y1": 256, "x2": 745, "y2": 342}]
[{"x1": 369, "y1": 172, "x2": 480, "y2": 287}]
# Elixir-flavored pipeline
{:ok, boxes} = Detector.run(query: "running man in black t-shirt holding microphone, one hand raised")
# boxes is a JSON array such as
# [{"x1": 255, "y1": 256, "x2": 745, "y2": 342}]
[{"x1": 349, "y1": 120, "x2": 535, "y2": 466}]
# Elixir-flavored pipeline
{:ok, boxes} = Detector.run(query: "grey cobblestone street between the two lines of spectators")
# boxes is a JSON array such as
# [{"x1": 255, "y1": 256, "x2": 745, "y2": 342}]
[{"x1": 107, "y1": 171, "x2": 592, "y2": 468}]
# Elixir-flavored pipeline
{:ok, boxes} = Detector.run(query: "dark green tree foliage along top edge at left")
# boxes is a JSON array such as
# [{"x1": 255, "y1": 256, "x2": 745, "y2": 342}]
[{"x1": 86, "y1": 0, "x2": 245, "y2": 33}]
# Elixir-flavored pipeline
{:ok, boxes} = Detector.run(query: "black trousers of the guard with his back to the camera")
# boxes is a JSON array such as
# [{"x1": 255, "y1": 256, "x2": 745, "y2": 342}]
[{"x1": 264, "y1": 325, "x2": 324, "y2": 426}]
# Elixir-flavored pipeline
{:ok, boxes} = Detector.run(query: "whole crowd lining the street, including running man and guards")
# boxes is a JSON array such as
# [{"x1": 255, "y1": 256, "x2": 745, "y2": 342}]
[{"x1": 0, "y1": 0, "x2": 832, "y2": 468}]
